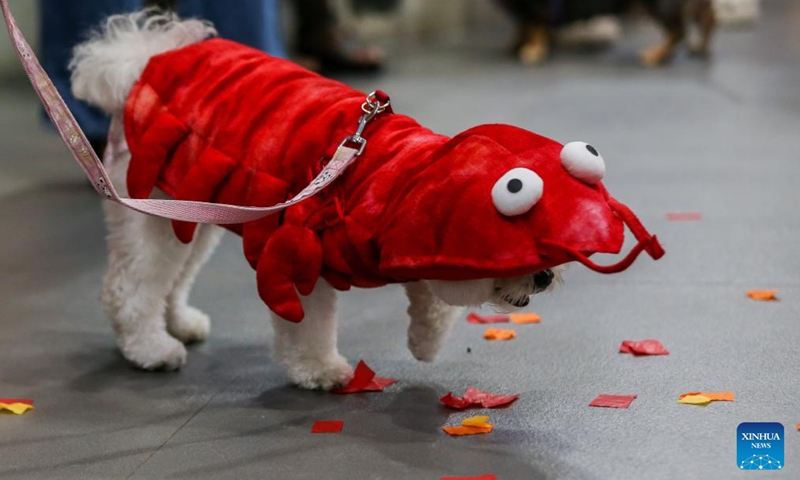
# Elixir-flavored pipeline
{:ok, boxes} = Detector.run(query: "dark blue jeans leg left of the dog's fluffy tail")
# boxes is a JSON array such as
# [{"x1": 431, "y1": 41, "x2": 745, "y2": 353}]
[{"x1": 39, "y1": 0, "x2": 142, "y2": 147}]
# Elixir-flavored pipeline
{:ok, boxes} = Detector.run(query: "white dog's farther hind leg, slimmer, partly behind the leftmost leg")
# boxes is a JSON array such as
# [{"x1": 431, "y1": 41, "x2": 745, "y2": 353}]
[{"x1": 166, "y1": 225, "x2": 224, "y2": 343}]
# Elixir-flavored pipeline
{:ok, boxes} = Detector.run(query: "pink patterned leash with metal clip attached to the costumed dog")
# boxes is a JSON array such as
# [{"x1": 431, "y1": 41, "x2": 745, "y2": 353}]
[{"x1": 0, "y1": 0, "x2": 389, "y2": 224}]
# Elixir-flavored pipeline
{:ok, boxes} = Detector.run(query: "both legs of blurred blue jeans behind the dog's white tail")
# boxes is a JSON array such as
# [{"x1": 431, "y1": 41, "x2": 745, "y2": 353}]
[{"x1": 39, "y1": 0, "x2": 286, "y2": 139}]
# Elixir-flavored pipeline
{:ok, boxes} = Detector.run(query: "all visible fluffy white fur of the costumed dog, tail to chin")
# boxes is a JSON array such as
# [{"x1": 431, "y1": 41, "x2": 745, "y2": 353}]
[{"x1": 72, "y1": 11, "x2": 552, "y2": 389}]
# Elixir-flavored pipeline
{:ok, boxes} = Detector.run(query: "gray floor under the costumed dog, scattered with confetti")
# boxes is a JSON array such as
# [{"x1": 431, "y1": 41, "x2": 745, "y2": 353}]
[{"x1": 0, "y1": 0, "x2": 800, "y2": 480}]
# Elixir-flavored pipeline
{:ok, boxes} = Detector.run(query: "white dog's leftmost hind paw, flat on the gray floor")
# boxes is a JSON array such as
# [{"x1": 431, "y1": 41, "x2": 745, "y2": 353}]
[{"x1": 120, "y1": 331, "x2": 186, "y2": 371}]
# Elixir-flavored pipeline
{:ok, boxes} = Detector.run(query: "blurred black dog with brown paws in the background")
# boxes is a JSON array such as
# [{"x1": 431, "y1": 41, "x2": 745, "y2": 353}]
[{"x1": 498, "y1": 0, "x2": 715, "y2": 66}]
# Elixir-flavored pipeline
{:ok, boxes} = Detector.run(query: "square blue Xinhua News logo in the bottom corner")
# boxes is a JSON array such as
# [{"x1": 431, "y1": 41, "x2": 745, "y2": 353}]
[{"x1": 736, "y1": 422, "x2": 784, "y2": 470}]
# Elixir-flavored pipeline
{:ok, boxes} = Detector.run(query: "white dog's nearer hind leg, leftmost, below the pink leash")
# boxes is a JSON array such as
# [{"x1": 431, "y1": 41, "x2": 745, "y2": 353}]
[{"x1": 101, "y1": 146, "x2": 192, "y2": 370}]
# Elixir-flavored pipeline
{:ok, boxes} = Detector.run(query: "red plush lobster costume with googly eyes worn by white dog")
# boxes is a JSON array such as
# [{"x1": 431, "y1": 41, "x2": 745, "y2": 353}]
[{"x1": 124, "y1": 39, "x2": 664, "y2": 322}]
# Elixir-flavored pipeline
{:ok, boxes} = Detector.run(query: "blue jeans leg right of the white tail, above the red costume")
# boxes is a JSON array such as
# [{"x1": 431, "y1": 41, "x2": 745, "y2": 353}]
[{"x1": 178, "y1": 0, "x2": 286, "y2": 57}]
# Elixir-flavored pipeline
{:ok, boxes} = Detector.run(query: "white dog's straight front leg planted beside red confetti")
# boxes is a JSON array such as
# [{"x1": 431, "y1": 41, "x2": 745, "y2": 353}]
[{"x1": 271, "y1": 279, "x2": 353, "y2": 390}]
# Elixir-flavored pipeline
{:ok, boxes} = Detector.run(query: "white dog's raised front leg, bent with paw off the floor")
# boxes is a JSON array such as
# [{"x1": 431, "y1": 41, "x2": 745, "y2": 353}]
[{"x1": 405, "y1": 281, "x2": 463, "y2": 362}]
